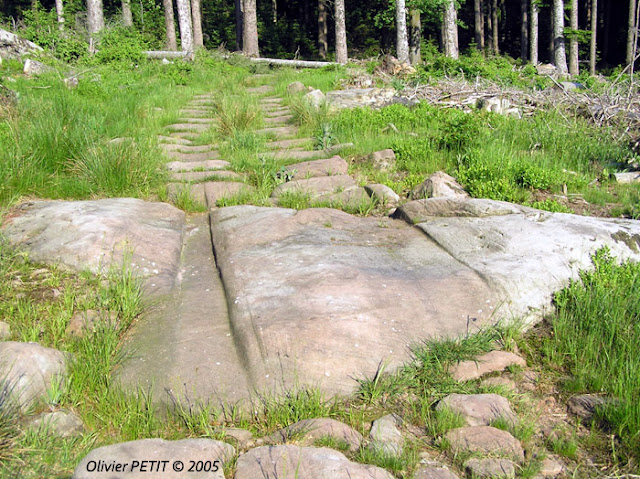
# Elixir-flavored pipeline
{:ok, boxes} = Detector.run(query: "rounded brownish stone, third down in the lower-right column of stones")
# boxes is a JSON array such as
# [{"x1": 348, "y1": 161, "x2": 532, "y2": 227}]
[{"x1": 445, "y1": 426, "x2": 524, "y2": 462}]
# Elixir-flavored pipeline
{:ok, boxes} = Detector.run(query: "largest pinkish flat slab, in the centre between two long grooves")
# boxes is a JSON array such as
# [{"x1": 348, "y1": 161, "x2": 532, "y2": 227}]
[{"x1": 211, "y1": 206, "x2": 492, "y2": 393}]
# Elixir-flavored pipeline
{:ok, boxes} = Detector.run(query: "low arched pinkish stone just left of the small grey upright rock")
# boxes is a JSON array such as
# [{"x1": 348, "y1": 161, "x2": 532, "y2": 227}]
[{"x1": 263, "y1": 418, "x2": 362, "y2": 452}]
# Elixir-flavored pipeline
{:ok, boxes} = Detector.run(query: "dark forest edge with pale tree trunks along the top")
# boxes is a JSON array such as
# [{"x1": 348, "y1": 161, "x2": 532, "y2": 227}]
[{"x1": 0, "y1": 0, "x2": 640, "y2": 74}]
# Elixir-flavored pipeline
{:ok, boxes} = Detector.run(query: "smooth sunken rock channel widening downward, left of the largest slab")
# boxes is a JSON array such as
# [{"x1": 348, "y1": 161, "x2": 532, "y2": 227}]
[{"x1": 119, "y1": 213, "x2": 251, "y2": 405}]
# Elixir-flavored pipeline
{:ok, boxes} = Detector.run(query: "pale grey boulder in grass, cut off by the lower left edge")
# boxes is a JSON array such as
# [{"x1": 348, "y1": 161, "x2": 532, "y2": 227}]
[{"x1": 0, "y1": 341, "x2": 67, "y2": 412}]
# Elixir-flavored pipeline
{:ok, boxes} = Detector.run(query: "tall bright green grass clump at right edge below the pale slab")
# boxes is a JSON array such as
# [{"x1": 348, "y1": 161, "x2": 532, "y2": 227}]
[{"x1": 544, "y1": 249, "x2": 640, "y2": 457}]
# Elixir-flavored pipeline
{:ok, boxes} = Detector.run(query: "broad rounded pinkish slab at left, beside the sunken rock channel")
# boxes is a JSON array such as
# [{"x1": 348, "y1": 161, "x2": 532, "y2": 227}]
[{"x1": 1, "y1": 198, "x2": 185, "y2": 291}]
